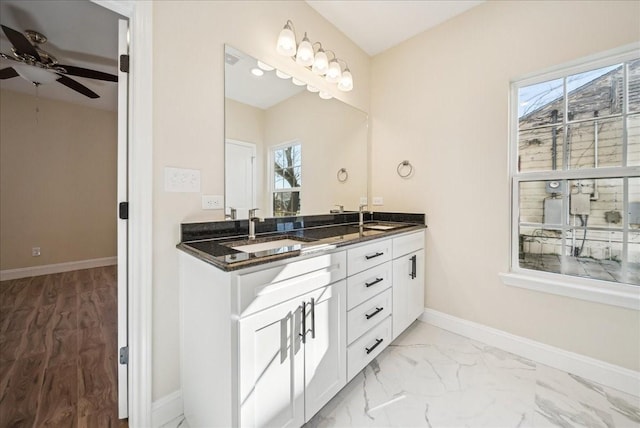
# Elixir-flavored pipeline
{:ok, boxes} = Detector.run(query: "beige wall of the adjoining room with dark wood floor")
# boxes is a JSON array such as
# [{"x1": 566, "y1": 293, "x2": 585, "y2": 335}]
[{"x1": 0, "y1": 90, "x2": 117, "y2": 270}]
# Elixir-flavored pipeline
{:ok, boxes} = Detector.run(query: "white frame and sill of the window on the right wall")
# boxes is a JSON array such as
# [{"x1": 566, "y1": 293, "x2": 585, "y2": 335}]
[{"x1": 499, "y1": 42, "x2": 640, "y2": 310}]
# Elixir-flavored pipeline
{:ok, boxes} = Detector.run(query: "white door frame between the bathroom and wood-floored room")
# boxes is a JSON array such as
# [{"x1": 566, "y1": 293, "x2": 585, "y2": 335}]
[{"x1": 90, "y1": 0, "x2": 153, "y2": 427}]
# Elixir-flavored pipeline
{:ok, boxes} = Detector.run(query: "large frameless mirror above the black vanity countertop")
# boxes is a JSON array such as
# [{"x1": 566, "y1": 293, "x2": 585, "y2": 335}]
[{"x1": 225, "y1": 46, "x2": 368, "y2": 218}]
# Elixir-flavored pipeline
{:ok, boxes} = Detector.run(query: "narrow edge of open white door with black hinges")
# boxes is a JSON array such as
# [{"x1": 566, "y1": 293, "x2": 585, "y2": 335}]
[{"x1": 115, "y1": 19, "x2": 129, "y2": 419}]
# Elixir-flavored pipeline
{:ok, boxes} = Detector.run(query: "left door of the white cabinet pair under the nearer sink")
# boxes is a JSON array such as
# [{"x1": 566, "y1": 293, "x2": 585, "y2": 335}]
[{"x1": 238, "y1": 297, "x2": 305, "y2": 428}]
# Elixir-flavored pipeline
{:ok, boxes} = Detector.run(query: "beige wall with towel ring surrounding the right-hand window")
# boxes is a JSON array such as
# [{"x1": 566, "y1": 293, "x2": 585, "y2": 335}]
[{"x1": 371, "y1": 1, "x2": 640, "y2": 370}]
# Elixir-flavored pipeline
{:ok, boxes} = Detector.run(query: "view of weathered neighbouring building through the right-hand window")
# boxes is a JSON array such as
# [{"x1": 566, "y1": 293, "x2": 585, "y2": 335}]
[{"x1": 511, "y1": 50, "x2": 640, "y2": 285}]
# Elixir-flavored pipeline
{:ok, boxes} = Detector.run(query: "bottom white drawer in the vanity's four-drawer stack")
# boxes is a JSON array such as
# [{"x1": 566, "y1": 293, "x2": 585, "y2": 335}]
[{"x1": 347, "y1": 317, "x2": 391, "y2": 382}]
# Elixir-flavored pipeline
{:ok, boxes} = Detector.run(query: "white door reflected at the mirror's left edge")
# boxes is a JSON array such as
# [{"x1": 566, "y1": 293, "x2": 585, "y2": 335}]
[{"x1": 224, "y1": 140, "x2": 258, "y2": 219}]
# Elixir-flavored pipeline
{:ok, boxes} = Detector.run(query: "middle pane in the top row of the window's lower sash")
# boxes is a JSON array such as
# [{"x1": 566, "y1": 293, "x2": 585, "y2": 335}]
[{"x1": 569, "y1": 178, "x2": 624, "y2": 229}]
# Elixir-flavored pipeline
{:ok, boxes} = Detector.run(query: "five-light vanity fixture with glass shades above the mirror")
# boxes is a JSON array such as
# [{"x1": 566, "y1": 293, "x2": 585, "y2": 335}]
[{"x1": 276, "y1": 20, "x2": 353, "y2": 99}]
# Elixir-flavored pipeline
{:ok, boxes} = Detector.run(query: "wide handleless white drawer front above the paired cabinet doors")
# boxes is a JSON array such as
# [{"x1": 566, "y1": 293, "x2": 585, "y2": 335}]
[{"x1": 235, "y1": 251, "x2": 347, "y2": 317}]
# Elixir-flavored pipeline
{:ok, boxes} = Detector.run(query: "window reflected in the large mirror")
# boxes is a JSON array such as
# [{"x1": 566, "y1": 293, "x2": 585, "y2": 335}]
[{"x1": 271, "y1": 142, "x2": 302, "y2": 217}]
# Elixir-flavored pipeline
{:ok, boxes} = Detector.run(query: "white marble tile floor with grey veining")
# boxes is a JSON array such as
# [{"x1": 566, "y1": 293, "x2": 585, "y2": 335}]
[{"x1": 164, "y1": 321, "x2": 640, "y2": 428}]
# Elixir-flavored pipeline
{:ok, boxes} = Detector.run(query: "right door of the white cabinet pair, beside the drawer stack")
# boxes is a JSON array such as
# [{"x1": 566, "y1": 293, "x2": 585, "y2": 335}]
[{"x1": 304, "y1": 281, "x2": 347, "y2": 421}]
